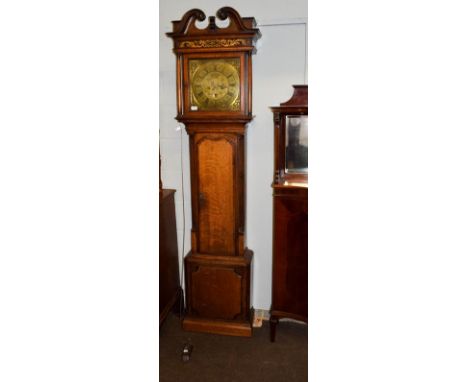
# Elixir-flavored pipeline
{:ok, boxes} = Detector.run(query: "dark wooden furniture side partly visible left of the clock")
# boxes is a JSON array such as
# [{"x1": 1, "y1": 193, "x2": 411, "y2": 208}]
[{"x1": 159, "y1": 189, "x2": 182, "y2": 326}]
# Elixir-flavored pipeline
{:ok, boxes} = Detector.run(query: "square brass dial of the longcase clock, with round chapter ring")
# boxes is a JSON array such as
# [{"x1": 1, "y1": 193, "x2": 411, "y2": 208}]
[{"x1": 189, "y1": 58, "x2": 240, "y2": 111}]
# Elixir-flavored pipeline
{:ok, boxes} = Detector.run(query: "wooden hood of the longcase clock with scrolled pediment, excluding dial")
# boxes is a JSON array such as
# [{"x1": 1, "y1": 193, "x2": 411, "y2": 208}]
[{"x1": 167, "y1": 7, "x2": 261, "y2": 123}]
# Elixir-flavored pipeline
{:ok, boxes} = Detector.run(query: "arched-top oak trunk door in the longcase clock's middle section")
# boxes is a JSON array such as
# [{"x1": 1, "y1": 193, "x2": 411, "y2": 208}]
[{"x1": 196, "y1": 133, "x2": 237, "y2": 255}]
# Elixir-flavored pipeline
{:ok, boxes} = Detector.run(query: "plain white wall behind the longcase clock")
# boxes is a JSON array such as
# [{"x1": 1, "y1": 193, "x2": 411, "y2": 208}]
[{"x1": 159, "y1": 0, "x2": 307, "y2": 309}]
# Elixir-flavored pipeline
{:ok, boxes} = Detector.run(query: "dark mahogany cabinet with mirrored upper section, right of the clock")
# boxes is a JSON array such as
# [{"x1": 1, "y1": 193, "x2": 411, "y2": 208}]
[{"x1": 270, "y1": 85, "x2": 308, "y2": 341}]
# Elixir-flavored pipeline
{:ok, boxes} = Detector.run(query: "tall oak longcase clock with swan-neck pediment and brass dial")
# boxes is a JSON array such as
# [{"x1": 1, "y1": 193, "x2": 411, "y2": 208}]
[{"x1": 167, "y1": 7, "x2": 261, "y2": 336}]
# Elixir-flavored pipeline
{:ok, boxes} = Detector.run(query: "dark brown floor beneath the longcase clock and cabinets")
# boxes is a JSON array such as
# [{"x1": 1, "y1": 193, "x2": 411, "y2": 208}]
[{"x1": 159, "y1": 314, "x2": 307, "y2": 382}]
